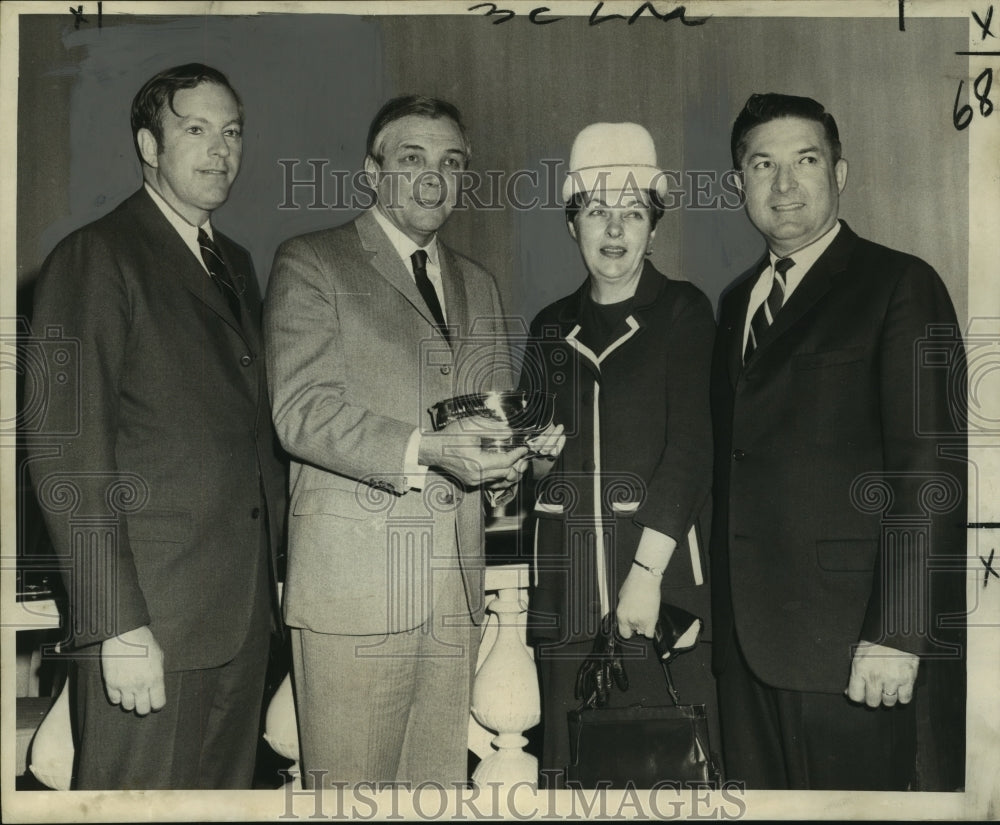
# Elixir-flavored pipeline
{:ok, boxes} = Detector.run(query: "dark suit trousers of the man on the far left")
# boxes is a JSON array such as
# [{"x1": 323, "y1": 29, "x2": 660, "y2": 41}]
[{"x1": 72, "y1": 552, "x2": 271, "y2": 790}]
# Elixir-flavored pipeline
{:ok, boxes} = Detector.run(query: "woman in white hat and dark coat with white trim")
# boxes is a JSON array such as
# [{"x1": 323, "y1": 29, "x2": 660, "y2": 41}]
[{"x1": 522, "y1": 123, "x2": 720, "y2": 787}]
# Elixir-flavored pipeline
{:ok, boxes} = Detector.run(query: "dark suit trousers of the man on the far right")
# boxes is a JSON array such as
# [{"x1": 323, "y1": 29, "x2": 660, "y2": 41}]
[{"x1": 718, "y1": 639, "x2": 916, "y2": 791}]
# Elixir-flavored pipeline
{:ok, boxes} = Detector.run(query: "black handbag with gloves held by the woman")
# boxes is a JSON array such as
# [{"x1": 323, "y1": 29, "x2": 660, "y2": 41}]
[{"x1": 566, "y1": 604, "x2": 721, "y2": 789}]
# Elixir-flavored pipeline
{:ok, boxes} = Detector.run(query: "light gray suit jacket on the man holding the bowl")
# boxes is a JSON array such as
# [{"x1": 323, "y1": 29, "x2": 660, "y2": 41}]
[{"x1": 264, "y1": 212, "x2": 515, "y2": 635}]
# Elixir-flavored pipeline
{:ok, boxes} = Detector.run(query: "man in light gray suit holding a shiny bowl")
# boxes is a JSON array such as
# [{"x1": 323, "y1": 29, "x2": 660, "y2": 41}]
[{"x1": 264, "y1": 96, "x2": 558, "y2": 787}]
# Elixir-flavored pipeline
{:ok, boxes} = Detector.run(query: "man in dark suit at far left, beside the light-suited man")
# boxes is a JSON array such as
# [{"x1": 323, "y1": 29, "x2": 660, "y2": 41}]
[{"x1": 32, "y1": 64, "x2": 285, "y2": 789}]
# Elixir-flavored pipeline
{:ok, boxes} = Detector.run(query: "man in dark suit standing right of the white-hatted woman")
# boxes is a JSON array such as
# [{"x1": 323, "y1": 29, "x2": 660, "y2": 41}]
[{"x1": 712, "y1": 94, "x2": 966, "y2": 790}]
